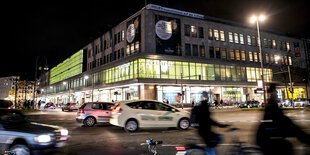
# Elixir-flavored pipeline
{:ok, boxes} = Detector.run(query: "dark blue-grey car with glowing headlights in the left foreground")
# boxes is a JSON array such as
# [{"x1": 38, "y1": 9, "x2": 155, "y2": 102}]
[{"x1": 0, "y1": 109, "x2": 69, "y2": 155}]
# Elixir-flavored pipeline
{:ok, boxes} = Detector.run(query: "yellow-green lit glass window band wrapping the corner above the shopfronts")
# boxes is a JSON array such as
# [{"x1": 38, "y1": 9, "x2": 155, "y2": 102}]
[{"x1": 103, "y1": 59, "x2": 272, "y2": 83}]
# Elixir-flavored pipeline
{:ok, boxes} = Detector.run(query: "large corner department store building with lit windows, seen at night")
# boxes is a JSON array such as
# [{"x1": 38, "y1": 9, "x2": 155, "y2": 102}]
[{"x1": 41, "y1": 4, "x2": 308, "y2": 104}]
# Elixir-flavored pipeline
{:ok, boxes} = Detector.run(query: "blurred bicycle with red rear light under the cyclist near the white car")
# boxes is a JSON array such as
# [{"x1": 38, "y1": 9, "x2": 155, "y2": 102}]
[{"x1": 176, "y1": 128, "x2": 263, "y2": 155}]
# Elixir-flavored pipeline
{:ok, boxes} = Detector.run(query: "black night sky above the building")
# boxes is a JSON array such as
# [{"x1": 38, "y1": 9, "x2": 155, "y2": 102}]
[{"x1": 0, "y1": 0, "x2": 310, "y2": 79}]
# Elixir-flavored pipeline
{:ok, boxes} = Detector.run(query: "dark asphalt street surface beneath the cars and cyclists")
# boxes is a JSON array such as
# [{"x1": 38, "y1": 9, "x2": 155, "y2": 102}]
[{"x1": 27, "y1": 110, "x2": 310, "y2": 155}]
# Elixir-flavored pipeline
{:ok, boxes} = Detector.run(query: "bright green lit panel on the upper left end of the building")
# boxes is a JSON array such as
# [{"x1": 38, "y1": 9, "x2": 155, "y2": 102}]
[{"x1": 49, "y1": 50, "x2": 83, "y2": 84}]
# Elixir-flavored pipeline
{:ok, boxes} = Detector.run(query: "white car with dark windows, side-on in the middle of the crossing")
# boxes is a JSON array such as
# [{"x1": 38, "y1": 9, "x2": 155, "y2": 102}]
[{"x1": 110, "y1": 100, "x2": 190, "y2": 132}]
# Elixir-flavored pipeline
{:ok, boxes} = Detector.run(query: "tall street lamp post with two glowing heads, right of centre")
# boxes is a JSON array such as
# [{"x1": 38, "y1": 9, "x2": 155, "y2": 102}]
[{"x1": 251, "y1": 15, "x2": 266, "y2": 104}]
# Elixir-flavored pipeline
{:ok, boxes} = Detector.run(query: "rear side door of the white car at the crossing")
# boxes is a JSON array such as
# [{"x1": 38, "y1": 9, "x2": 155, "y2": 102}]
[{"x1": 136, "y1": 101, "x2": 161, "y2": 127}]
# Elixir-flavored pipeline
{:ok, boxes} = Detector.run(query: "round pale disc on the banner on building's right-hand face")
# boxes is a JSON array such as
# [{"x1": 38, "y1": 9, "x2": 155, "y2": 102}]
[{"x1": 155, "y1": 20, "x2": 172, "y2": 40}]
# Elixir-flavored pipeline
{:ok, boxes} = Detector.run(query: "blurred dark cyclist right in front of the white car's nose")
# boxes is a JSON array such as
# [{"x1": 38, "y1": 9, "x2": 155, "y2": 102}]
[{"x1": 197, "y1": 91, "x2": 229, "y2": 151}]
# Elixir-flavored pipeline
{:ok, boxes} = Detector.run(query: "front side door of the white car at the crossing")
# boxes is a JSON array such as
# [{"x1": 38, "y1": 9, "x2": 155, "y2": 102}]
[{"x1": 155, "y1": 102, "x2": 180, "y2": 127}]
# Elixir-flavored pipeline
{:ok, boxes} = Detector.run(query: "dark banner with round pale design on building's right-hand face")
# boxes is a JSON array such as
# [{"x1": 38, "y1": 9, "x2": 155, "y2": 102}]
[{"x1": 155, "y1": 15, "x2": 182, "y2": 55}]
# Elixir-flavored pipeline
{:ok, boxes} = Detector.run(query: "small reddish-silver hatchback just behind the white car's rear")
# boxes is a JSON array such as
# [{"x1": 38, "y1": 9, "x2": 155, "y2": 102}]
[{"x1": 76, "y1": 102, "x2": 114, "y2": 127}]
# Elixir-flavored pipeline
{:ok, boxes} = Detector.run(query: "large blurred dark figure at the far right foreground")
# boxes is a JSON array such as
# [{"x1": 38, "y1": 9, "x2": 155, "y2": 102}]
[{"x1": 256, "y1": 84, "x2": 310, "y2": 155}]
